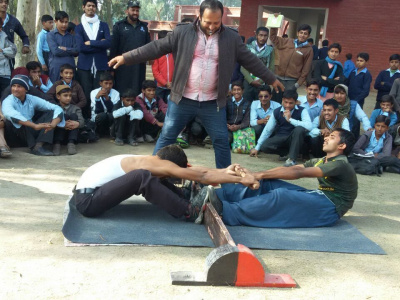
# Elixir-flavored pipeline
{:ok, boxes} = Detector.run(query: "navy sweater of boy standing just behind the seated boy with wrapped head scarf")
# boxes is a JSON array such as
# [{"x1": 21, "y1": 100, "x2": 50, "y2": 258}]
[{"x1": 347, "y1": 68, "x2": 372, "y2": 108}]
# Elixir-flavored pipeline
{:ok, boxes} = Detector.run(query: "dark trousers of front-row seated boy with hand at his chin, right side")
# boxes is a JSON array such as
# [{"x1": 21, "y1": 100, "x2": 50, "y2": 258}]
[{"x1": 260, "y1": 126, "x2": 307, "y2": 160}]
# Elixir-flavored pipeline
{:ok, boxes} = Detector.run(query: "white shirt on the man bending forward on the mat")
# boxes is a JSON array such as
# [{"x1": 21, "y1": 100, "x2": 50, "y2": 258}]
[{"x1": 76, "y1": 154, "x2": 140, "y2": 190}]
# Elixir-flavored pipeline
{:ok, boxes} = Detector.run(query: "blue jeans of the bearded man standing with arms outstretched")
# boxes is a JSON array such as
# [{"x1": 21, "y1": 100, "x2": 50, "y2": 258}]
[{"x1": 153, "y1": 98, "x2": 231, "y2": 168}]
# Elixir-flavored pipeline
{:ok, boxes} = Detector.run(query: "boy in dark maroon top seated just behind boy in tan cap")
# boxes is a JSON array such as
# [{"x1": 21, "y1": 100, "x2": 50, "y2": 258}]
[{"x1": 47, "y1": 64, "x2": 86, "y2": 109}]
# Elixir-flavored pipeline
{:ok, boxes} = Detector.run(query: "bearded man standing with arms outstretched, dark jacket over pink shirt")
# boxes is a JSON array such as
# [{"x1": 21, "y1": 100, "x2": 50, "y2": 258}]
[{"x1": 109, "y1": 0, "x2": 284, "y2": 168}]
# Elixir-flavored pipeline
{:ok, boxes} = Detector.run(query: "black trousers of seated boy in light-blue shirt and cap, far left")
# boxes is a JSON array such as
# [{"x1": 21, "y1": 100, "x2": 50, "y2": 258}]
[{"x1": 5, "y1": 111, "x2": 54, "y2": 148}]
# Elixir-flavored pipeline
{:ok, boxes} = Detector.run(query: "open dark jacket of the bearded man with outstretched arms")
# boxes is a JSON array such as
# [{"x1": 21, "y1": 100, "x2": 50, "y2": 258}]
[{"x1": 123, "y1": 21, "x2": 276, "y2": 107}]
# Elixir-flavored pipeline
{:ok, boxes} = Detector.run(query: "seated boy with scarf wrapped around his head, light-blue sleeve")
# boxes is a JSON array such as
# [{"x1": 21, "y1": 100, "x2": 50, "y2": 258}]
[{"x1": 334, "y1": 84, "x2": 372, "y2": 139}]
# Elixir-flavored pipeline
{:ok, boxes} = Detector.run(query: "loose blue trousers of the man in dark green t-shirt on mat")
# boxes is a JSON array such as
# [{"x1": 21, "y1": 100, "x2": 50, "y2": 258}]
[{"x1": 215, "y1": 180, "x2": 339, "y2": 228}]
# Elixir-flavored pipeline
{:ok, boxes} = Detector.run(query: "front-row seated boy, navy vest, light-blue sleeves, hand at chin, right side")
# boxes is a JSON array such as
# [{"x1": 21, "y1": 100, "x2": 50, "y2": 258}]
[{"x1": 250, "y1": 90, "x2": 312, "y2": 167}]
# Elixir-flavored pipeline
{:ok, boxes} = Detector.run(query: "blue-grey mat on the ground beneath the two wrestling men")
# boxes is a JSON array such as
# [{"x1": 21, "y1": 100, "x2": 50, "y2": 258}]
[{"x1": 62, "y1": 197, "x2": 386, "y2": 254}]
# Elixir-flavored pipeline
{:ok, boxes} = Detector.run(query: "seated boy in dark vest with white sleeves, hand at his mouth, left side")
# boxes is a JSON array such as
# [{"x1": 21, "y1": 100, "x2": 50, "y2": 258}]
[{"x1": 90, "y1": 72, "x2": 120, "y2": 135}]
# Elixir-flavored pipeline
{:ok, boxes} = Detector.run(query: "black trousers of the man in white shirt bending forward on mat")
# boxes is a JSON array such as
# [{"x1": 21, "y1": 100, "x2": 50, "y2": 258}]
[{"x1": 74, "y1": 170, "x2": 189, "y2": 218}]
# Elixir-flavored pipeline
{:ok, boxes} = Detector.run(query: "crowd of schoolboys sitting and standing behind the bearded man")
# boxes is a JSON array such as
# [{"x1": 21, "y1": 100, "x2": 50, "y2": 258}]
[{"x1": 0, "y1": 0, "x2": 400, "y2": 173}]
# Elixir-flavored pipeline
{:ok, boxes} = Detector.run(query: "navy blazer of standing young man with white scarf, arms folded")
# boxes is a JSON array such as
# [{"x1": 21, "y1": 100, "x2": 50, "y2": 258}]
[{"x1": 75, "y1": 21, "x2": 111, "y2": 71}]
